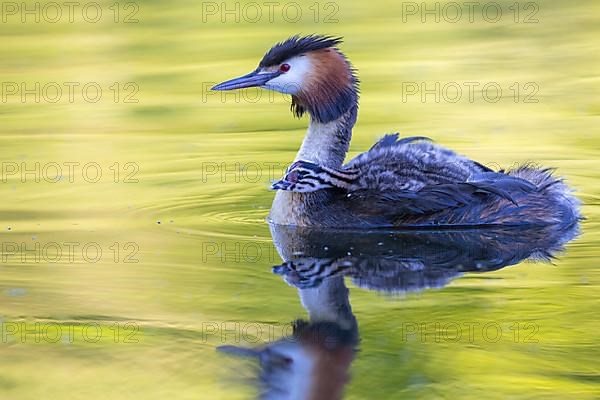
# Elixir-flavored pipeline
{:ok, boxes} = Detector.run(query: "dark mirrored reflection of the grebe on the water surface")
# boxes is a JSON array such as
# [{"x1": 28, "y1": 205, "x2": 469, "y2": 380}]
[{"x1": 219, "y1": 225, "x2": 578, "y2": 400}]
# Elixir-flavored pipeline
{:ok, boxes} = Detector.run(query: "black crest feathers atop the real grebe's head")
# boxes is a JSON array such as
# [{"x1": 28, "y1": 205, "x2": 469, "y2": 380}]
[{"x1": 258, "y1": 35, "x2": 342, "y2": 68}]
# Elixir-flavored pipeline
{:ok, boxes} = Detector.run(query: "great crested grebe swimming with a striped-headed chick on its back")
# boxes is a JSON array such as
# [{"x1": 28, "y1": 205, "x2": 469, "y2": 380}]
[{"x1": 212, "y1": 35, "x2": 581, "y2": 228}]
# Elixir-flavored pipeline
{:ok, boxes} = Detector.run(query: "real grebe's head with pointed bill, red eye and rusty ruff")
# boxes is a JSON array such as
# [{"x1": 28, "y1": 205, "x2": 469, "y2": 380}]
[{"x1": 212, "y1": 35, "x2": 358, "y2": 123}]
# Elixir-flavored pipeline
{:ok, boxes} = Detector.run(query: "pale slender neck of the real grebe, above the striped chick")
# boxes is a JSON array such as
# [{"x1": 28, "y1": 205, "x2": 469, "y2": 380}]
[{"x1": 295, "y1": 105, "x2": 358, "y2": 168}]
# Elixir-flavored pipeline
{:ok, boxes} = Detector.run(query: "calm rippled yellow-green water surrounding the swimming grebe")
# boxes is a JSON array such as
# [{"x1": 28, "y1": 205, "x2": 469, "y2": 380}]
[{"x1": 0, "y1": 0, "x2": 600, "y2": 400}]
